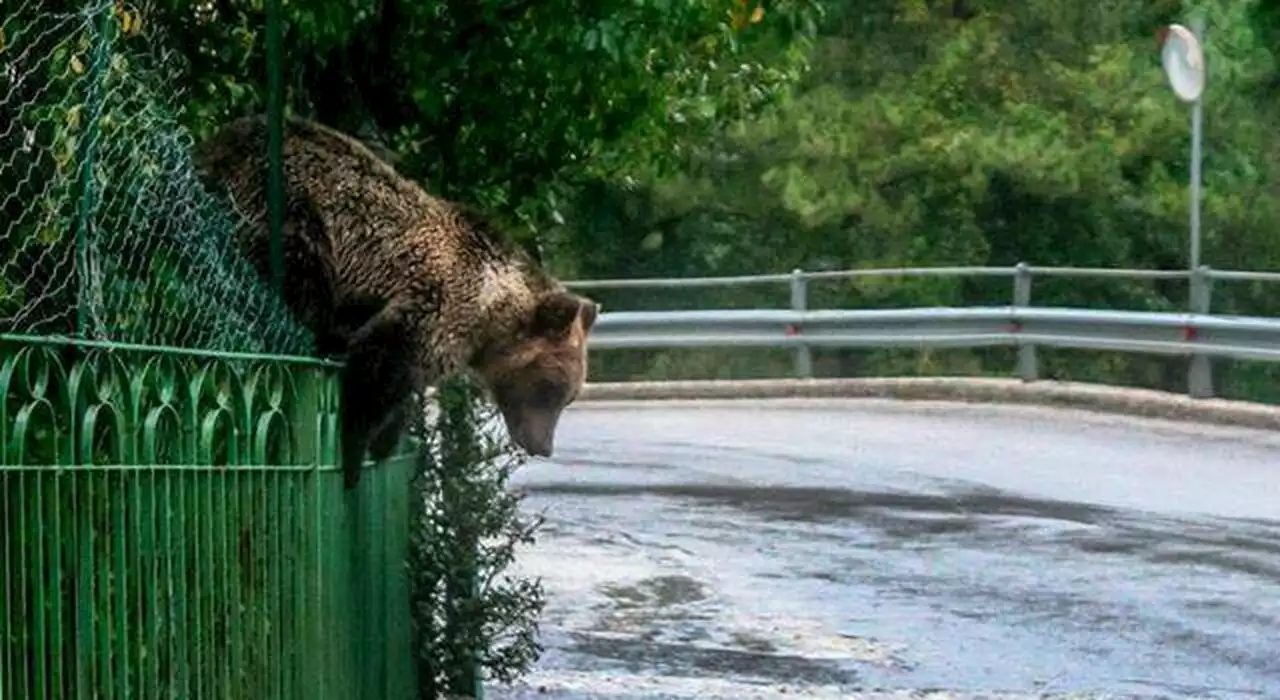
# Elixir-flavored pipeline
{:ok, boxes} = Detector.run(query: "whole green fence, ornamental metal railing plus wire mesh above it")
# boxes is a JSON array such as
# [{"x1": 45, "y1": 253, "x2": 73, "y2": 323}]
[{"x1": 0, "y1": 0, "x2": 430, "y2": 700}]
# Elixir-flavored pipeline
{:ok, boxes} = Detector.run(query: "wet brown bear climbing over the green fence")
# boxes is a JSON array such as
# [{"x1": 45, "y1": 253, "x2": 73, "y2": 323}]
[{"x1": 196, "y1": 116, "x2": 599, "y2": 488}]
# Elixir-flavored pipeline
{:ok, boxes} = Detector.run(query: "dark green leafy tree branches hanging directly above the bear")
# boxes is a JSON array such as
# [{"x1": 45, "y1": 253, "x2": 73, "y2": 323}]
[{"x1": 137, "y1": 0, "x2": 818, "y2": 257}]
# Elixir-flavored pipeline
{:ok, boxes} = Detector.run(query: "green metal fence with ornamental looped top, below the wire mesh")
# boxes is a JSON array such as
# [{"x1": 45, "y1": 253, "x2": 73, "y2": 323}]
[{"x1": 0, "y1": 337, "x2": 416, "y2": 700}]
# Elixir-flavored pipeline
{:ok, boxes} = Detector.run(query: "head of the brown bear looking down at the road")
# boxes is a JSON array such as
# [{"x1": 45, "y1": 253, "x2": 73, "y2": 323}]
[{"x1": 481, "y1": 289, "x2": 599, "y2": 457}]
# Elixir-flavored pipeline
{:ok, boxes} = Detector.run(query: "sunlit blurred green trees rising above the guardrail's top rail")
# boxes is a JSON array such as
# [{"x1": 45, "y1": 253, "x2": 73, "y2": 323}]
[{"x1": 570, "y1": 0, "x2": 1280, "y2": 285}]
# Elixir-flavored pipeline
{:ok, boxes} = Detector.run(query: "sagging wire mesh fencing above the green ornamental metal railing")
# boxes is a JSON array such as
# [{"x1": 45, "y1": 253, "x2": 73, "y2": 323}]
[{"x1": 0, "y1": 0, "x2": 311, "y2": 354}]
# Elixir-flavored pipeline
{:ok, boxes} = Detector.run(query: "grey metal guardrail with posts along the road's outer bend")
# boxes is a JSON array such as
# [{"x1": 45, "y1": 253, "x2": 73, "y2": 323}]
[{"x1": 568, "y1": 264, "x2": 1280, "y2": 398}]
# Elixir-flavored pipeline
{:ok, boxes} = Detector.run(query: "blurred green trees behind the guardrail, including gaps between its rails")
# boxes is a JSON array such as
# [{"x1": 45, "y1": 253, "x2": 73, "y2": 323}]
[{"x1": 572, "y1": 0, "x2": 1280, "y2": 399}]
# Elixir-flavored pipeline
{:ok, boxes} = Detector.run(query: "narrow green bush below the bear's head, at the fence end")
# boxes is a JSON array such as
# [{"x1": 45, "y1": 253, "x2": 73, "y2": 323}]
[{"x1": 408, "y1": 378, "x2": 544, "y2": 700}]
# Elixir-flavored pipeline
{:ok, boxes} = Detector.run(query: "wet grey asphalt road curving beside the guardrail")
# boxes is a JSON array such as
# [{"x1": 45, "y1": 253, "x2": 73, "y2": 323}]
[{"x1": 488, "y1": 401, "x2": 1280, "y2": 700}]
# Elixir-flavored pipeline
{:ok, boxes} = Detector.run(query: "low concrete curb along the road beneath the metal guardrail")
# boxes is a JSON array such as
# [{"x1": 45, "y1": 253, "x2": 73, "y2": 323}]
[{"x1": 579, "y1": 378, "x2": 1280, "y2": 430}]
